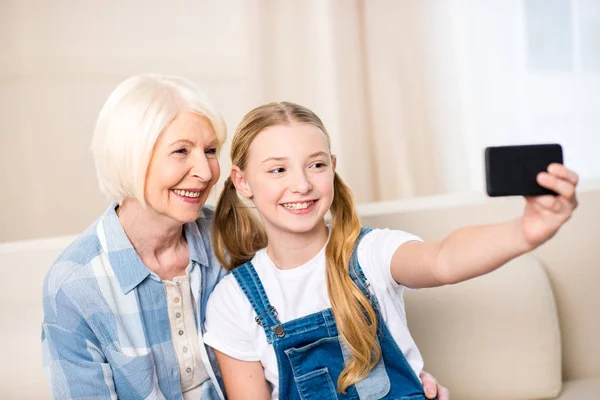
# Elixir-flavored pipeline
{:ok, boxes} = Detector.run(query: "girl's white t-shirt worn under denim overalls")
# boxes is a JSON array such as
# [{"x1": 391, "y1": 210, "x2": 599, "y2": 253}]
[{"x1": 204, "y1": 229, "x2": 423, "y2": 399}]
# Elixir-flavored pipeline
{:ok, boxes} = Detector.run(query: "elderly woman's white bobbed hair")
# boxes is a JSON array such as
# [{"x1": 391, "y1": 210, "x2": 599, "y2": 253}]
[{"x1": 92, "y1": 74, "x2": 227, "y2": 205}]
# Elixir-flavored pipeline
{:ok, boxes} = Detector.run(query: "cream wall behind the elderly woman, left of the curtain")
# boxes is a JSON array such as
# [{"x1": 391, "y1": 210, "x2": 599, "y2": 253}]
[{"x1": 0, "y1": 0, "x2": 257, "y2": 242}]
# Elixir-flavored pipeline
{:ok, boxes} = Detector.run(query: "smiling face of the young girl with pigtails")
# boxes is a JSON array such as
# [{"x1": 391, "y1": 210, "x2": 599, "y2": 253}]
[{"x1": 232, "y1": 123, "x2": 335, "y2": 237}]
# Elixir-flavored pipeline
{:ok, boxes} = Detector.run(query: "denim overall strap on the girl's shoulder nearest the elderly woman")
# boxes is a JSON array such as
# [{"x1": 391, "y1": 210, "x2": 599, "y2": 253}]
[{"x1": 231, "y1": 261, "x2": 285, "y2": 344}]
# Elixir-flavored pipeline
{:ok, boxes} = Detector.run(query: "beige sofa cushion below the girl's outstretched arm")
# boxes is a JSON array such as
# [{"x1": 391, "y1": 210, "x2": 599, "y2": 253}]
[{"x1": 405, "y1": 255, "x2": 562, "y2": 400}]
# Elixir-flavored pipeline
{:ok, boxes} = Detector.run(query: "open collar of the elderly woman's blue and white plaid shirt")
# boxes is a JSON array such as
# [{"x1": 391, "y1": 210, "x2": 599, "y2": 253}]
[{"x1": 98, "y1": 204, "x2": 208, "y2": 294}]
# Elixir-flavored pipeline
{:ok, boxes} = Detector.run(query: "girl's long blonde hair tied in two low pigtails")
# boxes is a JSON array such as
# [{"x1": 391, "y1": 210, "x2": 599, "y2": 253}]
[{"x1": 213, "y1": 102, "x2": 381, "y2": 393}]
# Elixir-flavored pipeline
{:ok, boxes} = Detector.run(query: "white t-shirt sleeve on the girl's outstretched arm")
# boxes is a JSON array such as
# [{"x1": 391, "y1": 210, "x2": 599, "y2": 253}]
[{"x1": 358, "y1": 229, "x2": 423, "y2": 290}]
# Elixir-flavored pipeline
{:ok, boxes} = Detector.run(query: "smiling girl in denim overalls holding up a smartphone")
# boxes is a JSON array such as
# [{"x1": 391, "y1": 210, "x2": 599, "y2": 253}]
[{"x1": 205, "y1": 103, "x2": 577, "y2": 400}]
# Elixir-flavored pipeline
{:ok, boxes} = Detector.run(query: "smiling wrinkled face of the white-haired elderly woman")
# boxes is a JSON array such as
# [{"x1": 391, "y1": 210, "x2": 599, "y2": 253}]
[{"x1": 144, "y1": 112, "x2": 221, "y2": 224}]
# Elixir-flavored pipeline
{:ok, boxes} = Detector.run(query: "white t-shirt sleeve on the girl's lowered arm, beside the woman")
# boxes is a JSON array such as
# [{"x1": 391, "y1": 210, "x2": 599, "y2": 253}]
[{"x1": 204, "y1": 274, "x2": 260, "y2": 361}]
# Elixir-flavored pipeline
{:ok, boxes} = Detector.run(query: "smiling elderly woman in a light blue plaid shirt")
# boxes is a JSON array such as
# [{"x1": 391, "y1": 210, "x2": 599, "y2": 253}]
[{"x1": 42, "y1": 75, "x2": 448, "y2": 400}]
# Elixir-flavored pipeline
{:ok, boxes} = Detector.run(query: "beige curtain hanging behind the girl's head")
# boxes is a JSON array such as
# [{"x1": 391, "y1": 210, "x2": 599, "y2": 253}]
[{"x1": 255, "y1": 0, "x2": 442, "y2": 203}]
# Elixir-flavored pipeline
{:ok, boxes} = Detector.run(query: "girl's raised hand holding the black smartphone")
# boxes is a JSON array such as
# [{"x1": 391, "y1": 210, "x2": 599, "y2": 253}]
[{"x1": 522, "y1": 164, "x2": 579, "y2": 249}]
